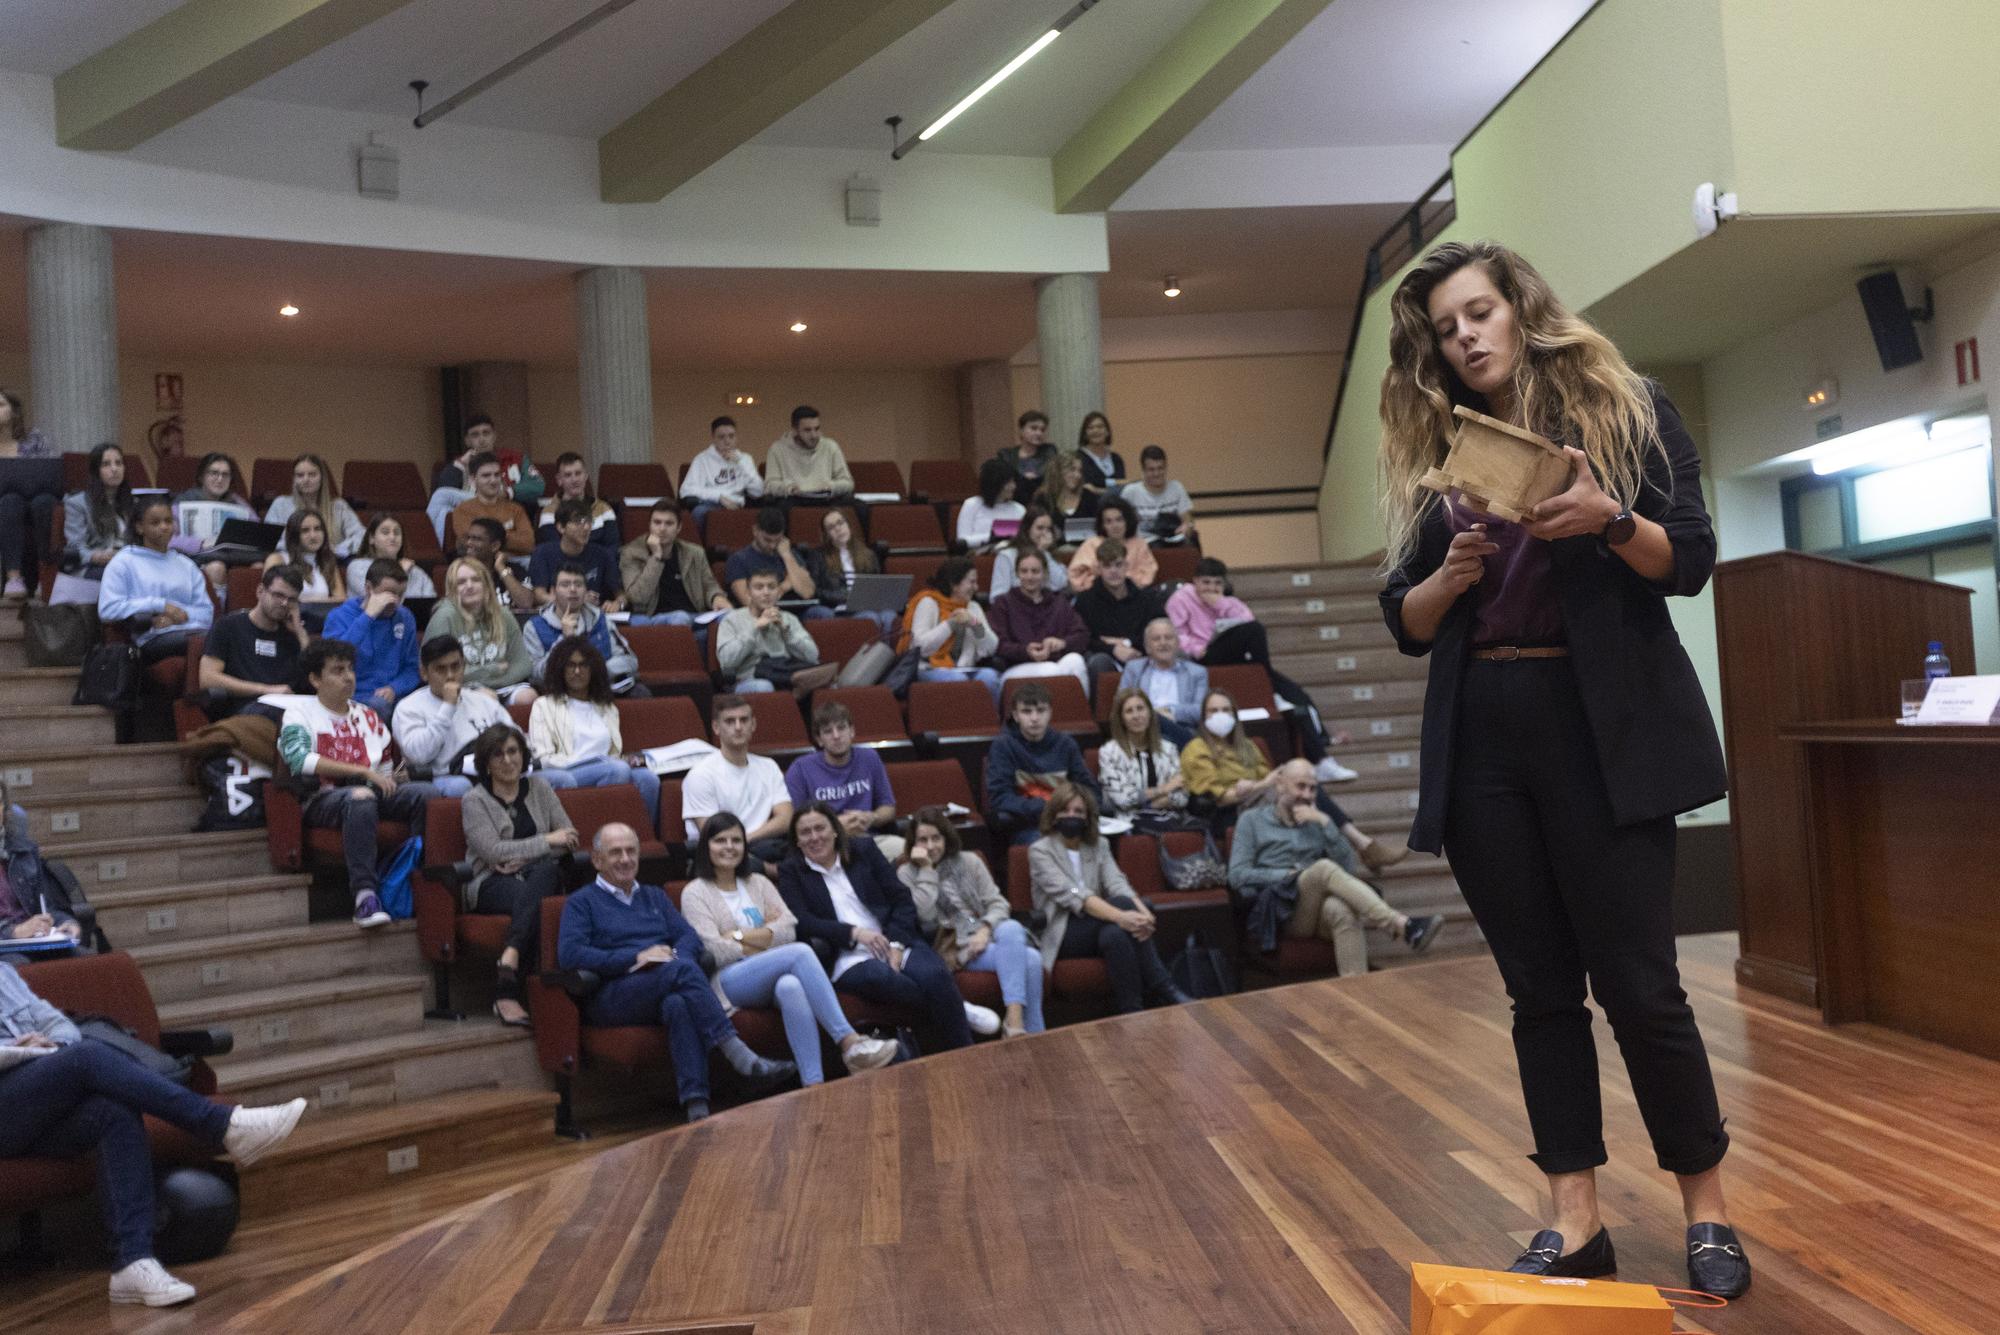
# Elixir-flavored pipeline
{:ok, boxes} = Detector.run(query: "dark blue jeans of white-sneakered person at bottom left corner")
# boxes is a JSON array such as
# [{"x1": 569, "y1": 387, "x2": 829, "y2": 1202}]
[{"x1": 0, "y1": 1039, "x2": 232, "y2": 1269}]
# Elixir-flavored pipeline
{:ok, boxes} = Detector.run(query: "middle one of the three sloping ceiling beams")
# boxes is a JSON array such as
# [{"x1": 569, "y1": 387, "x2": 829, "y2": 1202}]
[{"x1": 598, "y1": 0, "x2": 952, "y2": 204}]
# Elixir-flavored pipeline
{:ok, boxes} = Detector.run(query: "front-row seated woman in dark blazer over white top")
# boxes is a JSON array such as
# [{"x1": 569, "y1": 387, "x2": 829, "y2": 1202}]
[{"x1": 778, "y1": 801, "x2": 976, "y2": 1053}]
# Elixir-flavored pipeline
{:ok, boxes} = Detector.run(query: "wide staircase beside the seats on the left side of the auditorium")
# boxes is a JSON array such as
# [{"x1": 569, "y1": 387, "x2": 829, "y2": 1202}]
[{"x1": 0, "y1": 610, "x2": 556, "y2": 1211}]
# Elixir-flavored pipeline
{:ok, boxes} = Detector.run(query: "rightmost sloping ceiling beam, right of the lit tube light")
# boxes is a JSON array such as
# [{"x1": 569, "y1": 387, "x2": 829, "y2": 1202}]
[{"x1": 1054, "y1": 0, "x2": 1332, "y2": 214}]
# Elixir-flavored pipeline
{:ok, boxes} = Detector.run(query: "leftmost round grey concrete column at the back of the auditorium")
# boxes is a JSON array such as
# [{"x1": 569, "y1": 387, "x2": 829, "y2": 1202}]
[{"x1": 28, "y1": 222, "x2": 118, "y2": 454}]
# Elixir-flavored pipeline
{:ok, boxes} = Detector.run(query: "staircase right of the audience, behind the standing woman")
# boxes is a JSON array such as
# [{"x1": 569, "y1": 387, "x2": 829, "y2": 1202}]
[{"x1": 1230, "y1": 560, "x2": 1484, "y2": 967}]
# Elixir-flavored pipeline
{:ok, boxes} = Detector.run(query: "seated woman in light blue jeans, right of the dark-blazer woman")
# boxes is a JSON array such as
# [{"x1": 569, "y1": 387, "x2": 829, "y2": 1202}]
[{"x1": 896, "y1": 807, "x2": 1044, "y2": 1039}]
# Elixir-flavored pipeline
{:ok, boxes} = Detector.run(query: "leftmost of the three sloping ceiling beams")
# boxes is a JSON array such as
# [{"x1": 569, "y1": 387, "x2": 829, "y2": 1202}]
[{"x1": 56, "y1": 0, "x2": 410, "y2": 150}]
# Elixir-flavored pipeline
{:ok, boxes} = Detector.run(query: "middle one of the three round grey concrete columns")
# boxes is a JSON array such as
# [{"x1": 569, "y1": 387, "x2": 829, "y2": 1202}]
[{"x1": 576, "y1": 268, "x2": 652, "y2": 474}]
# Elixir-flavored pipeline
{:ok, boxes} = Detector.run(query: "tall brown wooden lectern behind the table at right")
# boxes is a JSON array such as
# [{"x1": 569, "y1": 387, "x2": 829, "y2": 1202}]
[{"x1": 1714, "y1": 552, "x2": 1972, "y2": 1005}]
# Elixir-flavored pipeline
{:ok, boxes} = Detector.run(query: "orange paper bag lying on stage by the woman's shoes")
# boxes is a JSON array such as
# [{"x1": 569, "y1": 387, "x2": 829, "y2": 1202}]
[{"x1": 1410, "y1": 1261, "x2": 1674, "y2": 1335}]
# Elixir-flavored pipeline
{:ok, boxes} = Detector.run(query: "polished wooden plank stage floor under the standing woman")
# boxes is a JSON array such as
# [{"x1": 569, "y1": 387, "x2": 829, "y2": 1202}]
[{"x1": 0, "y1": 937, "x2": 2000, "y2": 1335}]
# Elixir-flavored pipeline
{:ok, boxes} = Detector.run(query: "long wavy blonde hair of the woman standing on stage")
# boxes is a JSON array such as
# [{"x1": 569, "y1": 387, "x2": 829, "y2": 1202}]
[{"x1": 1382, "y1": 242, "x2": 1666, "y2": 570}]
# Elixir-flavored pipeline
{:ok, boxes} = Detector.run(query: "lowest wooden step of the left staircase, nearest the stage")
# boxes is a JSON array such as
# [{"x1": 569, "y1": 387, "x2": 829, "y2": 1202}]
[{"x1": 240, "y1": 1087, "x2": 560, "y2": 1215}]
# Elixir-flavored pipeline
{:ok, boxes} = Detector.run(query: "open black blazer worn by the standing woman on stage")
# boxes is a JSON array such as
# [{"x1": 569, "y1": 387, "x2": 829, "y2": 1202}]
[{"x1": 1382, "y1": 386, "x2": 1728, "y2": 853}]
